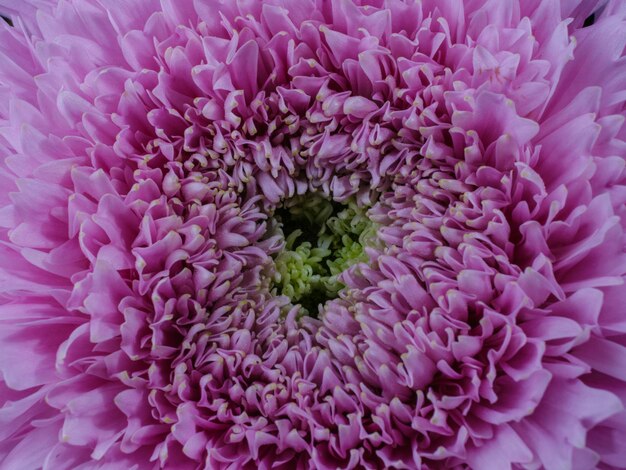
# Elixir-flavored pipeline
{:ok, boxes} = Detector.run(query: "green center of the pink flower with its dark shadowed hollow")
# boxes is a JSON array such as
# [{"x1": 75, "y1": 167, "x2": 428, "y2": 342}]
[{"x1": 273, "y1": 194, "x2": 375, "y2": 315}]
